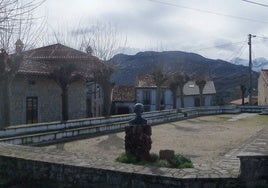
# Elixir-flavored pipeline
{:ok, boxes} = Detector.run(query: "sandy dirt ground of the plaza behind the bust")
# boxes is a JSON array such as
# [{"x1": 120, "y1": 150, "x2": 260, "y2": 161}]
[{"x1": 47, "y1": 114, "x2": 268, "y2": 166}]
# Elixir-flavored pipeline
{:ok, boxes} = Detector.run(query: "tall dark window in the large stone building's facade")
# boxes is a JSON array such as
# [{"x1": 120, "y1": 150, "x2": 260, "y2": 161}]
[{"x1": 26, "y1": 97, "x2": 38, "y2": 124}]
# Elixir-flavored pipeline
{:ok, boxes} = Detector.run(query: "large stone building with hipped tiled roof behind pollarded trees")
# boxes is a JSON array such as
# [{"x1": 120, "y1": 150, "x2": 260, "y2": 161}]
[{"x1": 0, "y1": 44, "x2": 104, "y2": 125}]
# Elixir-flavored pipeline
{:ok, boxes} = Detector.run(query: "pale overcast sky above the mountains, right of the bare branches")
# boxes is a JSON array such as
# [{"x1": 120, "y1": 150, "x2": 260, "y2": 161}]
[{"x1": 39, "y1": 0, "x2": 268, "y2": 60}]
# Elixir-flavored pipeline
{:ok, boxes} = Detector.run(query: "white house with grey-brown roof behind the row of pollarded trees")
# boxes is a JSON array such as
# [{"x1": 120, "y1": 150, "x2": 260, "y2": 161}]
[{"x1": 135, "y1": 76, "x2": 216, "y2": 111}]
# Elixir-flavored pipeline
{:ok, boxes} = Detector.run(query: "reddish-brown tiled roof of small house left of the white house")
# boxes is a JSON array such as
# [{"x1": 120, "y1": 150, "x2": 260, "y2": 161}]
[{"x1": 113, "y1": 85, "x2": 135, "y2": 102}]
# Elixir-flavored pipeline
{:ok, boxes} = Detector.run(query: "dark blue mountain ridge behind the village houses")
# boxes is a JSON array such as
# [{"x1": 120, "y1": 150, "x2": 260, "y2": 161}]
[{"x1": 108, "y1": 51, "x2": 258, "y2": 103}]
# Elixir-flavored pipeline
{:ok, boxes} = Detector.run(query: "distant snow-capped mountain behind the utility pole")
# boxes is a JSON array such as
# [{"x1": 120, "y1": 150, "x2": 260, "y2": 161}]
[{"x1": 231, "y1": 57, "x2": 268, "y2": 72}]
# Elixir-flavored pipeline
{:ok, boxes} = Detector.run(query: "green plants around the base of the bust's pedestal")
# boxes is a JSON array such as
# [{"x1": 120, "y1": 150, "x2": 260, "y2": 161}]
[{"x1": 115, "y1": 153, "x2": 193, "y2": 168}]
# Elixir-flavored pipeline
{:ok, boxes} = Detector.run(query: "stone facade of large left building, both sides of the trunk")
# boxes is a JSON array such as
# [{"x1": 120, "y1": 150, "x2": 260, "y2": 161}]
[{"x1": 10, "y1": 76, "x2": 86, "y2": 125}]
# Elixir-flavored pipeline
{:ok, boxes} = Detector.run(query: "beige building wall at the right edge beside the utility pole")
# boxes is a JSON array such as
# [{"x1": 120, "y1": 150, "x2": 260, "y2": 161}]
[{"x1": 258, "y1": 70, "x2": 268, "y2": 105}]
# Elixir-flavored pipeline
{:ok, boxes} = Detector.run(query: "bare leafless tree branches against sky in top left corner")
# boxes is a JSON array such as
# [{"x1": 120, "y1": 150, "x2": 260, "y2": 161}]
[{"x1": 0, "y1": 0, "x2": 45, "y2": 53}]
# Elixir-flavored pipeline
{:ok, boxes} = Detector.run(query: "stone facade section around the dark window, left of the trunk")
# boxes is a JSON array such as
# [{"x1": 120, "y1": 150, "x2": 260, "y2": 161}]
[{"x1": 10, "y1": 77, "x2": 61, "y2": 125}]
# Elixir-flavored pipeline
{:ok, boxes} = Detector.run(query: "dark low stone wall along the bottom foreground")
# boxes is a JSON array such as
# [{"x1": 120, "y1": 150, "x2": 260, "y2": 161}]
[{"x1": 0, "y1": 148, "x2": 238, "y2": 188}]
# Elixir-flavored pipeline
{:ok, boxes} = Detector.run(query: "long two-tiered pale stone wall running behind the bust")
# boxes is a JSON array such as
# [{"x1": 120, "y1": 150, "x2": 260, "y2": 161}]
[{"x1": 0, "y1": 110, "x2": 184, "y2": 145}]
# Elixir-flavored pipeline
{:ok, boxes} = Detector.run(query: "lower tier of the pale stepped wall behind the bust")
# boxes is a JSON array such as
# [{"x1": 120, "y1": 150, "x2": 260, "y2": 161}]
[{"x1": 0, "y1": 111, "x2": 184, "y2": 145}]
